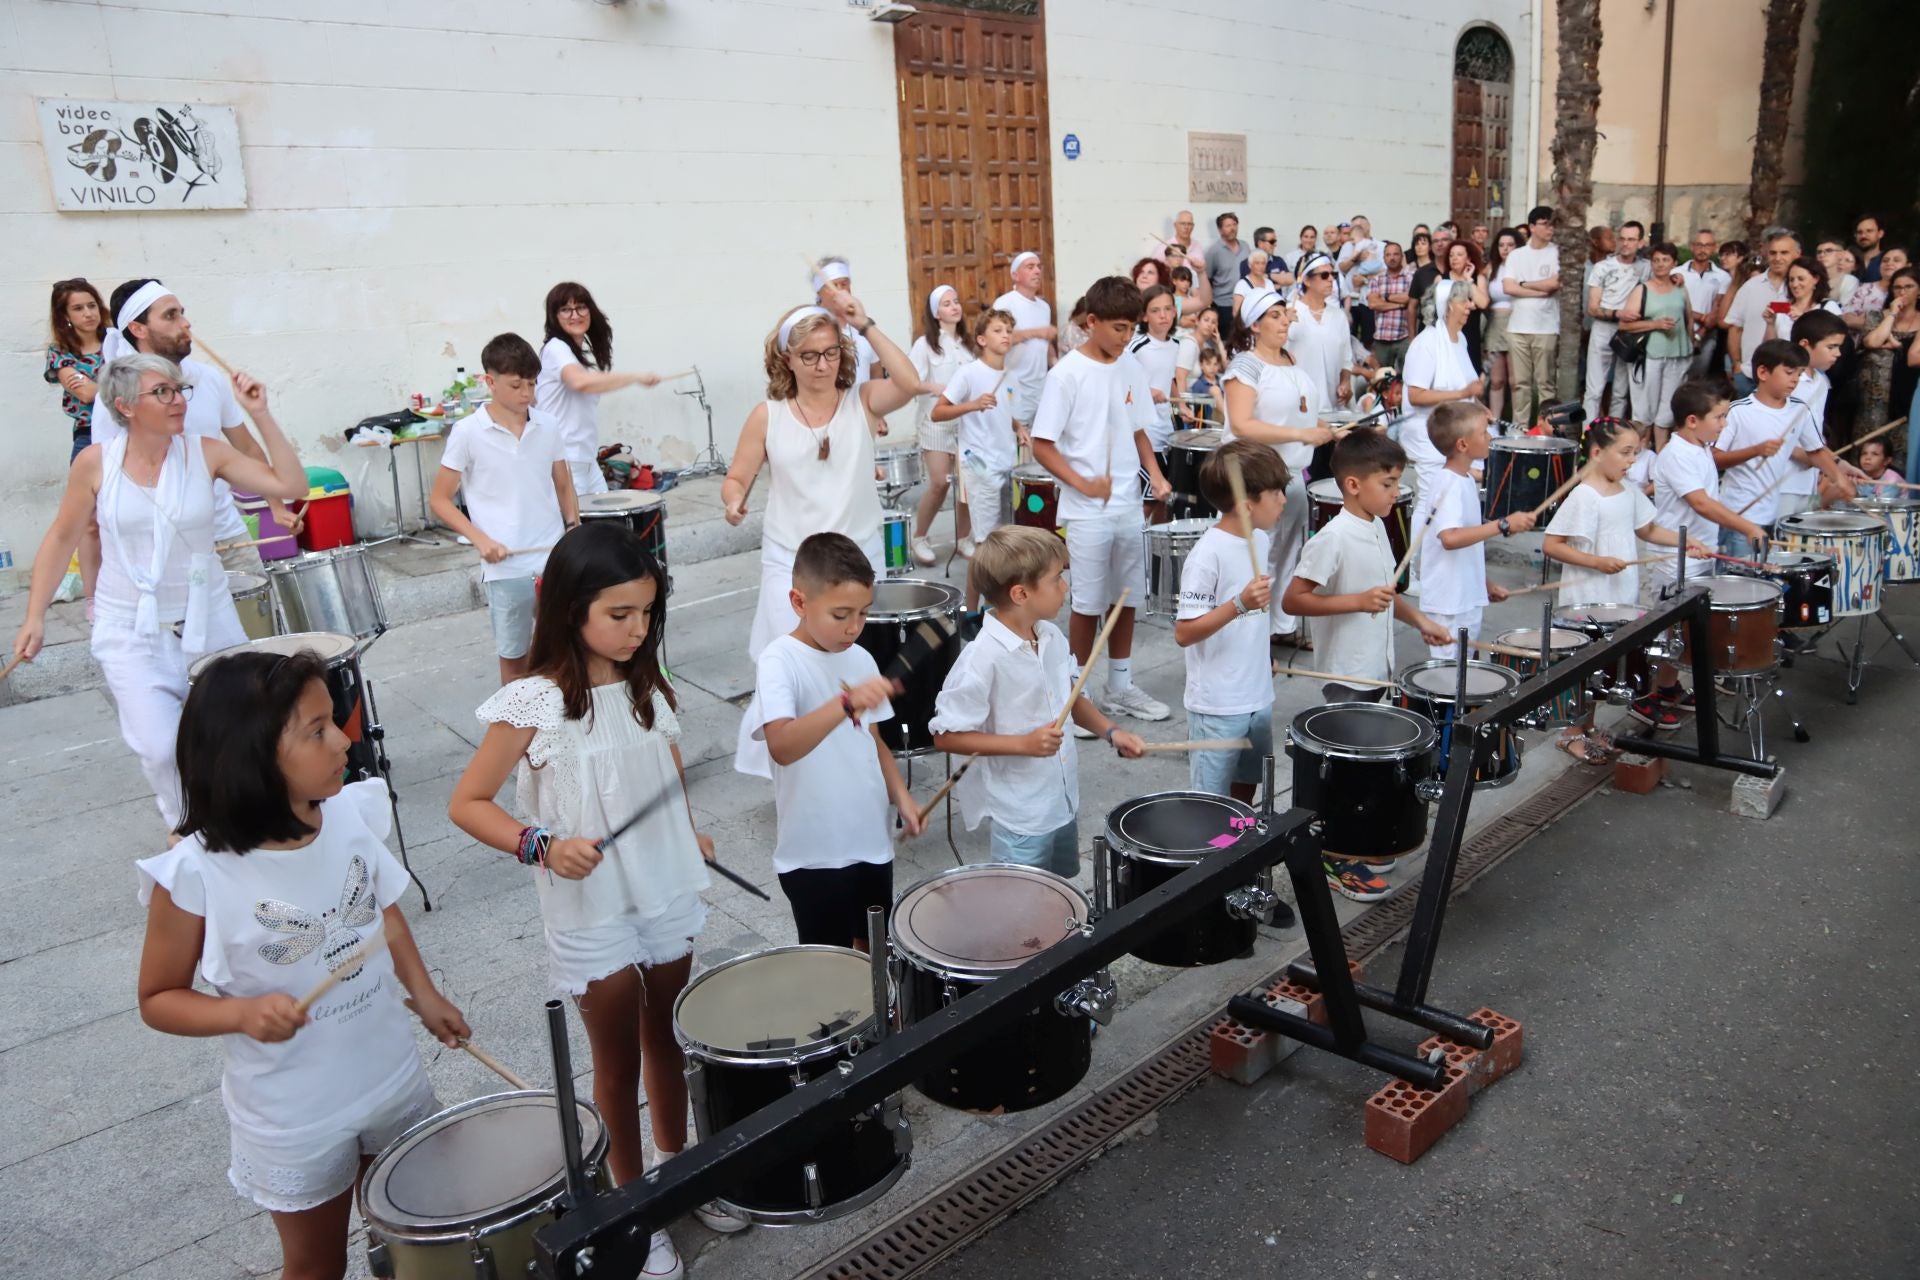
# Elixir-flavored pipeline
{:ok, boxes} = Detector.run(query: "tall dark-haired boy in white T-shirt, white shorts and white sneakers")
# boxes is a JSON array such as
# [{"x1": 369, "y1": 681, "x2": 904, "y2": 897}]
[{"x1": 1033, "y1": 276, "x2": 1173, "y2": 720}]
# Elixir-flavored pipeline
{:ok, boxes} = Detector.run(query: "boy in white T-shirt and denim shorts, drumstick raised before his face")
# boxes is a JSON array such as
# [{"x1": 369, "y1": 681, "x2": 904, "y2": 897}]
[{"x1": 1173, "y1": 439, "x2": 1290, "y2": 804}]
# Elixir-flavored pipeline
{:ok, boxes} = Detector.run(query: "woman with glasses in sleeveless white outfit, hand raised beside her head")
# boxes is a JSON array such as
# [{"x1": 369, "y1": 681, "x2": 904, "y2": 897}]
[{"x1": 720, "y1": 290, "x2": 920, "y2": 662}]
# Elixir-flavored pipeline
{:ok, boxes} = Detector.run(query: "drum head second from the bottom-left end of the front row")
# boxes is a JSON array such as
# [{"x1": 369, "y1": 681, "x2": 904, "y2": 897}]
[{"x1": 674, "y1": 946, "x2": 874, "y2": 1057}]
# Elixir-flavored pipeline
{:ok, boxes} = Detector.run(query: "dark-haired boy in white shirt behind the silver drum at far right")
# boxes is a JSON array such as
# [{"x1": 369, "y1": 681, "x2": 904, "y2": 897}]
[{"x1": 1713, "y1": 338, "x2": 1853, "y2": 560}]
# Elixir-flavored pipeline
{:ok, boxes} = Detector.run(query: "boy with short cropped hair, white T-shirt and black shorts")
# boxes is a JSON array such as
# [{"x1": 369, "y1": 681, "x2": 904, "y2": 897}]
[{"x1": 735, "y1": 533, "x2": 920, "y2": 950}]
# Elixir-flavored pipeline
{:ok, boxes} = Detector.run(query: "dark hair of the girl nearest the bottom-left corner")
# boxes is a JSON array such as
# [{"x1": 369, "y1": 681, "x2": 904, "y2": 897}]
[{"x1": 173, "y1": 649, "x2": 326, "y2": 854}]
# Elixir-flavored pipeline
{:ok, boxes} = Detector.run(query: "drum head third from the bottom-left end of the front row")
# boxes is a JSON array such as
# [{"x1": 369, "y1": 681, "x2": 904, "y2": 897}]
[{"x1": 893, "y1": 864, "x2": 1089, "y2": 979}]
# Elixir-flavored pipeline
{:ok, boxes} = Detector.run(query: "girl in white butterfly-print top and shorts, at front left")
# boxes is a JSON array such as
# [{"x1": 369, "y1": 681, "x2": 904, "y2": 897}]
[{"x1": 138, "y1": 652, "x2": 470, "y2": 1280}]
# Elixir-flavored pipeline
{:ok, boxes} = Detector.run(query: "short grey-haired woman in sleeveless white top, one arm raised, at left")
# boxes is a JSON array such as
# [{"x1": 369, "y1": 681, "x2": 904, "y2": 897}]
[{"x1": 13, "y1": 355, "x2": 307, "y2": 831}]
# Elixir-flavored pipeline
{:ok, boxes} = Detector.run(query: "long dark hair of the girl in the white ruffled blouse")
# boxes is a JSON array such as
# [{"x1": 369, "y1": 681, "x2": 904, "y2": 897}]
[{"x1": 526, "y1": 520, "x2": 680, "y2": 729}]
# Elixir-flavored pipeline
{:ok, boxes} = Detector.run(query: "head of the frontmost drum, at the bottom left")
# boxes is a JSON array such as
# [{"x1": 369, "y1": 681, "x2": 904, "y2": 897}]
[{"x1": 361, "y1": 1092, "x2": 601, "y2": 1234}]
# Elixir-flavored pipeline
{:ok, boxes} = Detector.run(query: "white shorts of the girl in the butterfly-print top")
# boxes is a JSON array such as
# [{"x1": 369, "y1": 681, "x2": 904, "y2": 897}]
[{"x1": 227, "y1": 1063, "x2": 440, "y2": 1213}]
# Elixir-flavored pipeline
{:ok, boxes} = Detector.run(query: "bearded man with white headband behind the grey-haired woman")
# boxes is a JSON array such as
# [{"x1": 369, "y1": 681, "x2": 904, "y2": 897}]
[{"x1": 92, "y1": 280, "x2": 301, "y2": 574}]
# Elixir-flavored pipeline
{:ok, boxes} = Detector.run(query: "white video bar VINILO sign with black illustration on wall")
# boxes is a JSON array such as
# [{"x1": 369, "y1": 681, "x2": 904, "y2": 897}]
[{"x1": 40, "y1": 98, "x2": 246, "y2": 213}]
